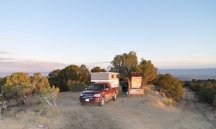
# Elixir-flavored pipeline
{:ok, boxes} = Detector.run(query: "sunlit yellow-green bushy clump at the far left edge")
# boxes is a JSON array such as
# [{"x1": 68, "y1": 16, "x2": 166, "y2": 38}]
[{"x1": 2, "y1": 73, "x2": 59, "y2": 104}]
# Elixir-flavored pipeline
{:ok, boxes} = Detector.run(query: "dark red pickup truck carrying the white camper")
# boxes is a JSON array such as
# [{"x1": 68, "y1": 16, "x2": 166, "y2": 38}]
[{"x1": 79, "y1": 82, "x2": 118, "y2": 106}]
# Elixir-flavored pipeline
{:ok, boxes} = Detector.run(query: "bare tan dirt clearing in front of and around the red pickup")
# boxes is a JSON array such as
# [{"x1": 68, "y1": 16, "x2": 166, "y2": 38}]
[{"x1": 0, "y1": 89, "x2": 216, "y2": 129}]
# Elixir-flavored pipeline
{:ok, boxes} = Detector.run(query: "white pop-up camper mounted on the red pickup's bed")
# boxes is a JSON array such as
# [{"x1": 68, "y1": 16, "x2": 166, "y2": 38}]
[{"x1": 91, "y1": 72, "x2": 119, "y2": 88}]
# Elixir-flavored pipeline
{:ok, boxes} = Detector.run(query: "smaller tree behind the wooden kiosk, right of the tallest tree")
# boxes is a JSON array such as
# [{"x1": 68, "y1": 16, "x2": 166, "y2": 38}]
[{"x1": 139, "y1": 58, "x2": 158, "y2": 83}]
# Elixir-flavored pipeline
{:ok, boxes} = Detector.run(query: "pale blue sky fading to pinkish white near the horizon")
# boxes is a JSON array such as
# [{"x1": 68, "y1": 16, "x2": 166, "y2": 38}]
[{"x1": 0, "y1": 0, "x2": 216, "y2": 73}]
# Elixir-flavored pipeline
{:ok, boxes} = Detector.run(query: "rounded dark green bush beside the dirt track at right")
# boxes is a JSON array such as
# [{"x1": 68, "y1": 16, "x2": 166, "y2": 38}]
[{"x1": 155, "y1": 74, "x2": 184, "y2": 101}]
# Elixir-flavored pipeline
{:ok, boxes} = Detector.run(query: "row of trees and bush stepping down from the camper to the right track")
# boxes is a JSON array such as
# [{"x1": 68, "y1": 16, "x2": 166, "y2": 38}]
[{"x1": 110, "y1": 51, "x2": 184, "y2": 101}]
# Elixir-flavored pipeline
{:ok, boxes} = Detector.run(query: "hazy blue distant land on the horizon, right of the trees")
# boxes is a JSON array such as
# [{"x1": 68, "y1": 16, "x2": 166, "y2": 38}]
[{"x1": 159, "y1": 68, "x2": 216, "y2": 80}]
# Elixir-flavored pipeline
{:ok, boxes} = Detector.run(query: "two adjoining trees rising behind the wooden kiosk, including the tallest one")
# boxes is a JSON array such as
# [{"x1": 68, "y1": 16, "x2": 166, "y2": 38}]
[{"x1": 110, "y1": 51, "x2": 158, "y2": 84}]
